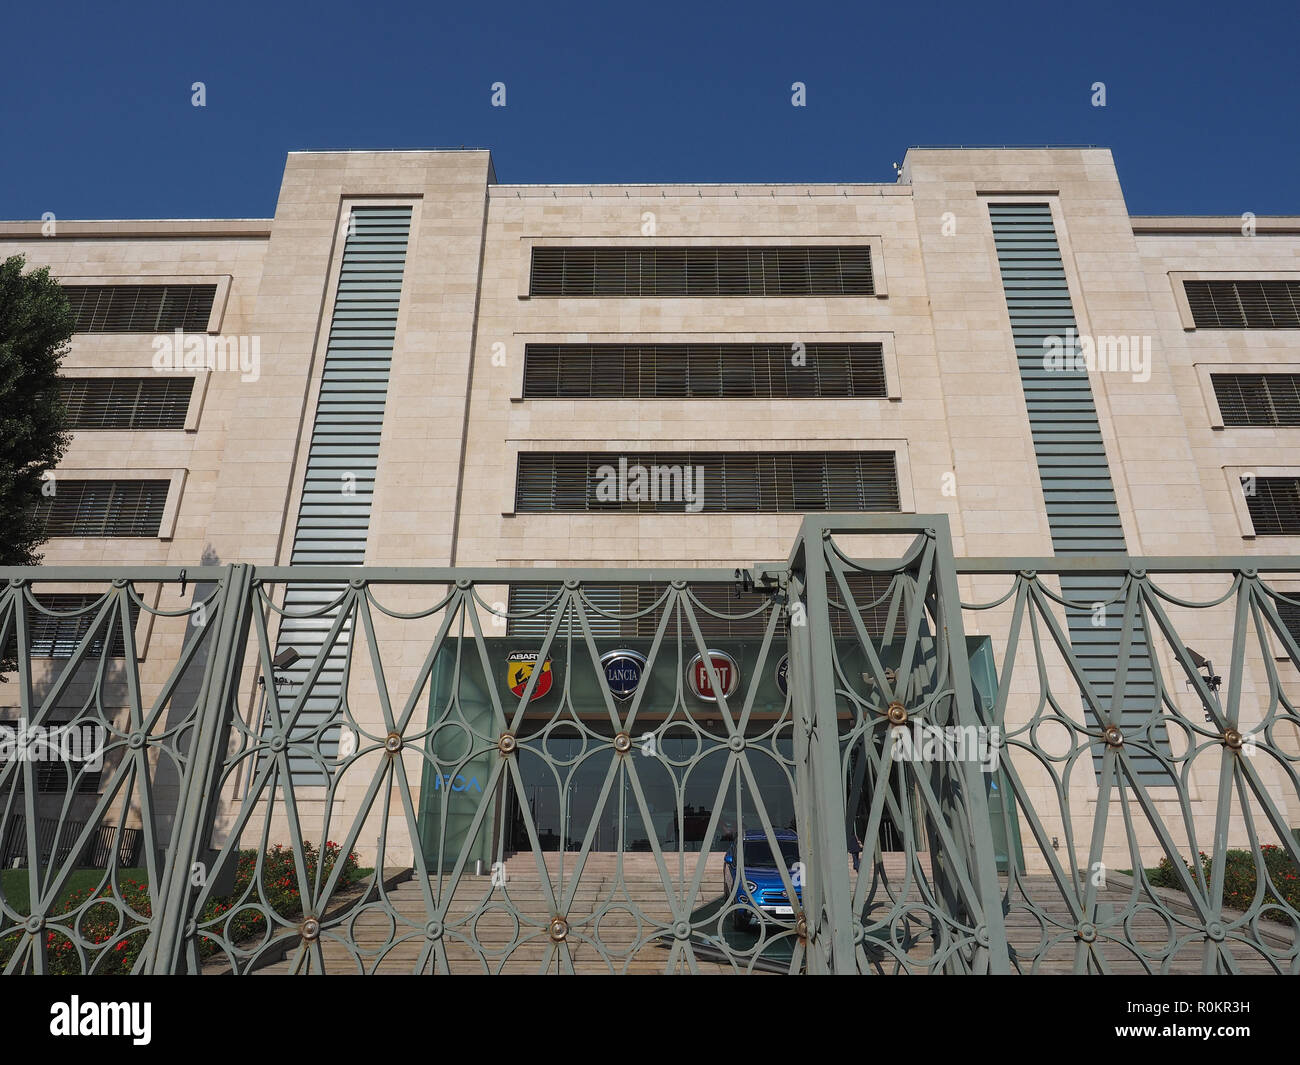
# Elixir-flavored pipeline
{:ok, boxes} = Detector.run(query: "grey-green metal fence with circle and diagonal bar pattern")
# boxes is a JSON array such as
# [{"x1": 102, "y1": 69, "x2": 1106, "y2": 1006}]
[{"x1": 0, "y1": 515, "x2": 1300, "y2": 974}]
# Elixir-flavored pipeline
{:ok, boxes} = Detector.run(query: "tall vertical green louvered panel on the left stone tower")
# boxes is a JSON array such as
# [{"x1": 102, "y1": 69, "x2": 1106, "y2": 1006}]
[{"x1": 277, "y1": 207, "x2": 411, "y2": 787}]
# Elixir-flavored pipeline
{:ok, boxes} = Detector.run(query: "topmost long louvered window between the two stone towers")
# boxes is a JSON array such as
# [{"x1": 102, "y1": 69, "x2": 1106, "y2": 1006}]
[{"x1": 528, "y1": 244, "x2": 875, "y2": 296}]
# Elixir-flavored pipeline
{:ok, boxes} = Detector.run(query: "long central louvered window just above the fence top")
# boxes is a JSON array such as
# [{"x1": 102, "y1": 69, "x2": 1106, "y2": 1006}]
[{"x1": 515, "y1": 451, "x2": 898, "y2": 514}]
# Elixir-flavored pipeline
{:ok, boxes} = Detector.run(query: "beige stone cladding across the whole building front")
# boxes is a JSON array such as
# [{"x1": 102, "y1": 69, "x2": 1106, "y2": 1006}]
[{"x1": 0, "y1": 148, "x2": 1300, "y2": 867}]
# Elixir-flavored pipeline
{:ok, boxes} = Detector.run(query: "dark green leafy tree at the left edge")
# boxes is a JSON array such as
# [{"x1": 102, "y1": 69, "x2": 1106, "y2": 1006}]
[{"x1": 0, "y1": 255, "x2": 75, "y2": 566}]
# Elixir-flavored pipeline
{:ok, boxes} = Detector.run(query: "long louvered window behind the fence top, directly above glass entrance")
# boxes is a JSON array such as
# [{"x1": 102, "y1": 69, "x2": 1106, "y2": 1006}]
[{"x1": 506, "y1": 573, "x2": 901, "y2": 642}]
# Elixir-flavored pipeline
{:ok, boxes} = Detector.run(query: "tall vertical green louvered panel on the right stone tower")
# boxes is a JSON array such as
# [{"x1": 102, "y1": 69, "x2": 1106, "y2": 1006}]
[{"x1": 989, "y1": 203, "x2": 1171, "y2": 785}]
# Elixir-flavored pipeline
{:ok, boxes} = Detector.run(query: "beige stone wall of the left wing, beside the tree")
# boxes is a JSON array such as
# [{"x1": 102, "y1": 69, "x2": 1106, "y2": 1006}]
[{"x1": 0, "y1": 220, "x2": 270, "y2": 842}]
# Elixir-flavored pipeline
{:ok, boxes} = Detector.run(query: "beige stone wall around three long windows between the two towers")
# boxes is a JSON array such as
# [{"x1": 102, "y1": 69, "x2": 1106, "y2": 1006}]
[{"x1": 467, "y1": 185, "x2": 952, "y2": 566}]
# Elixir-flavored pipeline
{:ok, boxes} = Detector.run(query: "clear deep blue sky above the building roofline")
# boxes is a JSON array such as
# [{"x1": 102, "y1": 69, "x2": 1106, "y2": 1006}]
[{"x1": 0, "y1": 0, "x2": 1300, "y2": 218}]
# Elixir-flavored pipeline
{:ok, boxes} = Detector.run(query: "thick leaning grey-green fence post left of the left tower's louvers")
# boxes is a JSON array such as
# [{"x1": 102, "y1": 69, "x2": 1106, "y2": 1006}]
[{"x1": 138, "y1": 564, "x2": 254, "y2": 975}]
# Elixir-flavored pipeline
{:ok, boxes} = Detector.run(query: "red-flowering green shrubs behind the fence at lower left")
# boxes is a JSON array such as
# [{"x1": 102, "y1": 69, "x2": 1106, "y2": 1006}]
[{"x1": 0, "y1": 843, "x2": 363, "y2": 974}]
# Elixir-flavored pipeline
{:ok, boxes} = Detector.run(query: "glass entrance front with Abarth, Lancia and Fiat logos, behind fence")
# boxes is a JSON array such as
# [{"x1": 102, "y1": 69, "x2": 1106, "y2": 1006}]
[{"x1": 421, "y1": 637, "x2": 991, "y2": 867}]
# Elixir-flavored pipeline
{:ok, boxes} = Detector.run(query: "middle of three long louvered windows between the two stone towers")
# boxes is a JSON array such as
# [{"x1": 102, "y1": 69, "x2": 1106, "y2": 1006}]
[{"x1": 524, "y1": 343, "x2": 887, "y2": 399}]
